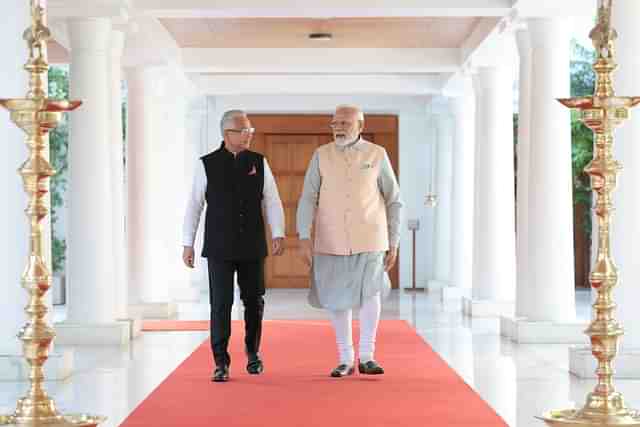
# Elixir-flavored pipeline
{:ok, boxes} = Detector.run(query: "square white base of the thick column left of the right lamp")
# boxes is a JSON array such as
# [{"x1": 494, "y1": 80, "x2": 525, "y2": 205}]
[{"x1": 500, "y1": 316, "x2": 589, "y2": 344}]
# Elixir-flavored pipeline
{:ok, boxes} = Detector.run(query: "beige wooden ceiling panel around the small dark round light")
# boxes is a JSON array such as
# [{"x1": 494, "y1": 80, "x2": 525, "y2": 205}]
[{"x1": 160, "y1": 17, "x2": 479, "y2": 49}]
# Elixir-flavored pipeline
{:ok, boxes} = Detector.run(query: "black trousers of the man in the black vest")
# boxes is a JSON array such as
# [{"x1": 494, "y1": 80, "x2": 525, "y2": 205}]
[{"x1": 207, "y1": 258, "x2": 265, "y2": 366}]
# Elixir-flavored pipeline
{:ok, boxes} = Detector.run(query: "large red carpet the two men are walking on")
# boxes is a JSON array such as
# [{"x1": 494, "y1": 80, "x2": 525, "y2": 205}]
[{"x1": 122, "y1": 320, "x2": 507, "y2": 427}]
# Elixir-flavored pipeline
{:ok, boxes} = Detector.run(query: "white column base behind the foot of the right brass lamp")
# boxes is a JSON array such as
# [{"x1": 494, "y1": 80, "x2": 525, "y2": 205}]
[{"x1": 569, "y1": 346, "x2": 640, "y2": 380}]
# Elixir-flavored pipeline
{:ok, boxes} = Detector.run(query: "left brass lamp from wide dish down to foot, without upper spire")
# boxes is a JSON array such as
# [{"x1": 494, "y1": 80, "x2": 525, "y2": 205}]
[{"x1": 0, "y1": 98, "x2": 106, "y2": 427}]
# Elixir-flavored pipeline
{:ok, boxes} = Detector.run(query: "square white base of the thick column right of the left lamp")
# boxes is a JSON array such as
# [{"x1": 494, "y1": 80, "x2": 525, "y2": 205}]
[{"x1": 54, "y1": 321, "x2": 131, "y2": 346}]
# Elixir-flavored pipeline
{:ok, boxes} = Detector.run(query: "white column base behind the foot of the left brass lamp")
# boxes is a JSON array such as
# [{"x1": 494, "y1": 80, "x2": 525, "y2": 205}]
[{"x1": 0, "y1": 349, "x2": 74, "y2": 381}]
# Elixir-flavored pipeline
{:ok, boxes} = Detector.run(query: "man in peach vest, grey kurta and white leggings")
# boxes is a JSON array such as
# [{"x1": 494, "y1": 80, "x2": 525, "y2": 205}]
[{"x1": 297, "y1": 105, "x2": 402, "y2": 377}]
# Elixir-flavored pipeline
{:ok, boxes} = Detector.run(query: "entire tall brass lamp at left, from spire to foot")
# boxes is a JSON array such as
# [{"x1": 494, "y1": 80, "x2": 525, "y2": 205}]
[{"x1": 0, "y1": 0, "x2": 106, "y2": 427}]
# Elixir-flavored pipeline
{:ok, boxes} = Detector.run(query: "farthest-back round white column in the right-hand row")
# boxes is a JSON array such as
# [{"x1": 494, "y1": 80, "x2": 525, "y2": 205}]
[{"x1": 443, "y1": 83, "x2": 474, "y2": 299}]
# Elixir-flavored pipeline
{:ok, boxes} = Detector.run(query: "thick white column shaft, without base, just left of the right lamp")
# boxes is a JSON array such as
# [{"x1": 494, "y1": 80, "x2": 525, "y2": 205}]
[{"x1": 526, "y1": 19, "x2": 575, "y2": 322}]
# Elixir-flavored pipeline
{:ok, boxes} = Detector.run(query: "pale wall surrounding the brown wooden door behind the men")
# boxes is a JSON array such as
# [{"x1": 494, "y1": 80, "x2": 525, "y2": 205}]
[{"x1": 202, "y1": 95, "x2": 433, "y2": 287}]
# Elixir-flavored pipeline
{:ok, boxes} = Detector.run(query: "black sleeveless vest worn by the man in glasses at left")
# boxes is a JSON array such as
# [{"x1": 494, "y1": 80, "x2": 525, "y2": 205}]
[{"x1": 201, "y1": 142, "x2": 267, "y2": 260}]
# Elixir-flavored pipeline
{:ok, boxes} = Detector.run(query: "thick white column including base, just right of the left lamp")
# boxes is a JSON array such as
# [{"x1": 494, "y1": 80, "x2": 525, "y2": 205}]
[{"x1": 58, "y1": 18, "x2": 129, "y2": 344}]
